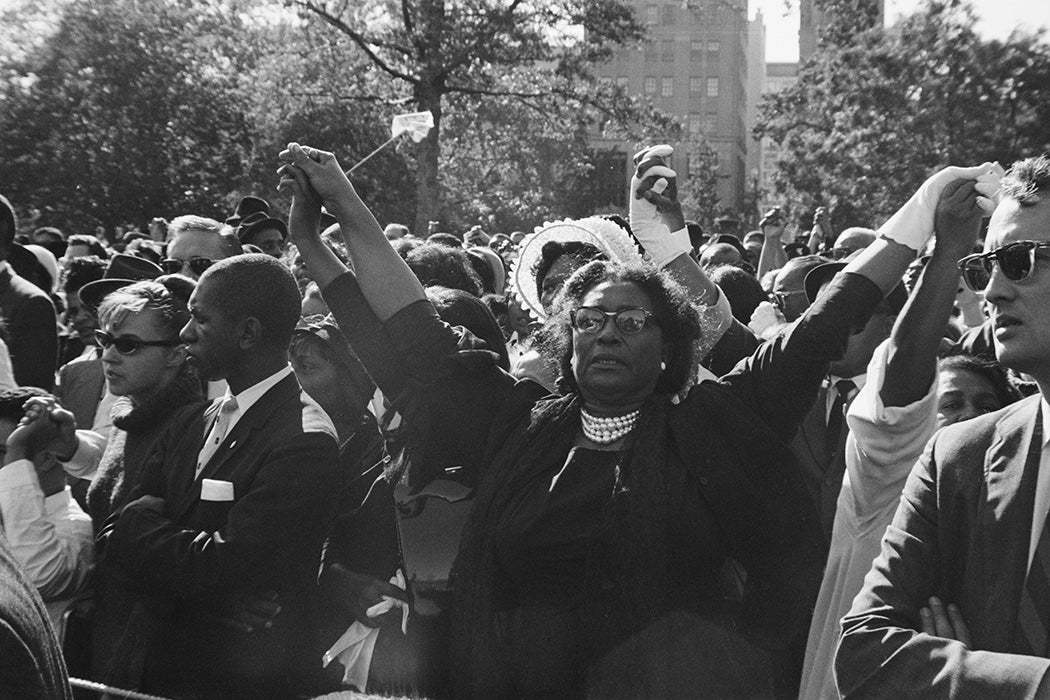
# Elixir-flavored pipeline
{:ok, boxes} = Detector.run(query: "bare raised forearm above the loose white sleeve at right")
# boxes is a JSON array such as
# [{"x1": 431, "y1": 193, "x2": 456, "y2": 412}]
[{"x1": 881, "y1": 252, "x2": 959, "y2": 406}]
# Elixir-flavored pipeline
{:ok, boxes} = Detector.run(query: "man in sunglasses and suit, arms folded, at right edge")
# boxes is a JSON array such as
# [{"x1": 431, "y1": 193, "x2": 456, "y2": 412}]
[{"x1": 836, "y1": 155, "x2": 1050, "y2": 698}]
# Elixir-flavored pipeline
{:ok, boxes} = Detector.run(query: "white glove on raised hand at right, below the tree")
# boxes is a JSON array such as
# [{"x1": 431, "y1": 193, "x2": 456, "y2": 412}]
[{"x1": 879, "y1": 163, "x2": 1003, "y2": 253}]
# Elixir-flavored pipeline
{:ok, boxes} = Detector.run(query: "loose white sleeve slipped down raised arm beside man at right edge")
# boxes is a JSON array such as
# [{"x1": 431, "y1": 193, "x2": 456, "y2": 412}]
[{"x1": 845, "y1": 340, "x2": 937, "y2": 517}]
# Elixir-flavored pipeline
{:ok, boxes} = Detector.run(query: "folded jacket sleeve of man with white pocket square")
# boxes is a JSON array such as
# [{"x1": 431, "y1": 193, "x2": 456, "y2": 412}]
[{"x1": 99, "y1": 432, "x2": 341, "y2": 598}]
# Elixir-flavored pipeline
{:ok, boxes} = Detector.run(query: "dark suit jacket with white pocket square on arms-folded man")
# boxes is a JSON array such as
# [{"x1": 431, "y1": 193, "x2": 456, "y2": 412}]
[{"x1": 100, "y1": 376, "x2": 343, "y2": 697}]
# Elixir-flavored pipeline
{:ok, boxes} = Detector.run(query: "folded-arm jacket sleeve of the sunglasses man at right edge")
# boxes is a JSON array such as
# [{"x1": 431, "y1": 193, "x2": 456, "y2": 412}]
[{"x1": 835, "y1": 432, "x2": 1050, "y2": 698}]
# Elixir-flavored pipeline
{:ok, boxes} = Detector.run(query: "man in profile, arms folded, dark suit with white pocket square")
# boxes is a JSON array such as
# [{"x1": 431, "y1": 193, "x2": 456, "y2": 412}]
[{"x1": 99, "y1": 254, "x2": 343, "y2": 698}]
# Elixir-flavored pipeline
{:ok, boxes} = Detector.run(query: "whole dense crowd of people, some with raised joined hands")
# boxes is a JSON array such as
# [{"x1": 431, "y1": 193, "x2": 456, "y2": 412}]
[{"x1": 0, "y1": 144, "x2": 1050, "y2": 699}]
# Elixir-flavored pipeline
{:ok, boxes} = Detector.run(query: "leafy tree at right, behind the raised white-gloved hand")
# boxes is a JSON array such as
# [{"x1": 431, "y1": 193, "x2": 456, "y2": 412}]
[{"x1": 756, "y1": 0, "x2": 1050, "y2": 230}]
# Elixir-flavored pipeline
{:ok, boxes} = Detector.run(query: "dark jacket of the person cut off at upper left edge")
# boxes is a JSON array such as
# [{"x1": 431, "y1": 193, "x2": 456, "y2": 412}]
[{"x1": 0, "y1": 261, "x2": 59, "y2": 391}]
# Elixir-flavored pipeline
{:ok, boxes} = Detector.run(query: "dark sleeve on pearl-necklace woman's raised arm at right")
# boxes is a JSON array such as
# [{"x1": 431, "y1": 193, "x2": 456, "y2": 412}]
[{"x1": 721, "y1": 273, "x2": 882, "y2": 442}]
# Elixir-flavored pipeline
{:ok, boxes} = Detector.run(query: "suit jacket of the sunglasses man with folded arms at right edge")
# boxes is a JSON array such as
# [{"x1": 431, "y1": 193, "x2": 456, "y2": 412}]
[{"x1": 835, "y1": 396, "x2": 1050, "y2": 698}]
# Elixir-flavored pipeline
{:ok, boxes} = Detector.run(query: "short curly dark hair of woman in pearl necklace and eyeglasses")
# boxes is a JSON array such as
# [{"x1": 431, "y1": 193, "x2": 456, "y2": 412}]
[{"x1": 542, "y1": 260, "x2": 700, "y2": 395}]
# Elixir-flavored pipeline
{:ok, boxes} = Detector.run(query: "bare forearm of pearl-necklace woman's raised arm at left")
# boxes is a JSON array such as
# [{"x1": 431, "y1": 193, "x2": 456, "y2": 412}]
[{"x1": 329, "y1": 188, "x2": 426, "y2": 321}]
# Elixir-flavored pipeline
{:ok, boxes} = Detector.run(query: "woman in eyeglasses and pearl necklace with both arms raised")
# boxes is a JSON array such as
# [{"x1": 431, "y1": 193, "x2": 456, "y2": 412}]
[{"x1": 281, "y1": 144, "x2": 961, "y2": 698}]
